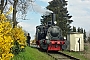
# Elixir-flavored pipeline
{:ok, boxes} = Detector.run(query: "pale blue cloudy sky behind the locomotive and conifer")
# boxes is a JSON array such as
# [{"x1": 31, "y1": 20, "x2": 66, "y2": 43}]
[{"x1": 19, "y1": 0, "x2": 90, "y2": 40}]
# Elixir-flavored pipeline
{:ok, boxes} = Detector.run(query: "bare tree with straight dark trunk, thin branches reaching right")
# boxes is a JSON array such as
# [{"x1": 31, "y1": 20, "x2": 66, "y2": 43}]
[{"x1": 13, "y1": 0, "x2": 32, "y2": 27}]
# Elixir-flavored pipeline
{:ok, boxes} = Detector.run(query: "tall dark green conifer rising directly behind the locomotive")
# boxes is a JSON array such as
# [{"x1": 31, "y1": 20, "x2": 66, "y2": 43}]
[{"x1": 42, "y1": 0, "x2": 73, "y2": 36}]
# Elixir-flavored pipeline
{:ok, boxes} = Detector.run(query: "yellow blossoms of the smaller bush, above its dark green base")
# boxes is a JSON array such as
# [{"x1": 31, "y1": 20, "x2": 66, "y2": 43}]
[{"x1": 12, "y1": 27, "x2": 26, "y2": 48}]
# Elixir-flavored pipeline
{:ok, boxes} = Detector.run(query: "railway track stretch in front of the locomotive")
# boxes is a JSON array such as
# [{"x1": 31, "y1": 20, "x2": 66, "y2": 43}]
[{"x1": 47, "y1": 52, "x2": 80, "y2": 60}]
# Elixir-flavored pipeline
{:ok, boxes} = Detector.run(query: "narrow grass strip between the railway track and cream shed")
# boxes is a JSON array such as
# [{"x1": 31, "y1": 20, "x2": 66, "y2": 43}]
[{"x1": 63, "y1": 51, "x2": 88, "y2": 60}]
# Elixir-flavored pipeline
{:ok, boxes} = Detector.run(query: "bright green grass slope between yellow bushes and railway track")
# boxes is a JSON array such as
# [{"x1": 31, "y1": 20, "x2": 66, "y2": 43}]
[{"x1": 11, "y1": 47, "x2": 53, "y2": 60}]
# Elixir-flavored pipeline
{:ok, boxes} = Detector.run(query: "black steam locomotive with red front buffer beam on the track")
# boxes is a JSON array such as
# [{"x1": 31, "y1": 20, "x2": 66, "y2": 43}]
[{"x1": 36, "y1": 13, "x2": 66, "y2": 51}]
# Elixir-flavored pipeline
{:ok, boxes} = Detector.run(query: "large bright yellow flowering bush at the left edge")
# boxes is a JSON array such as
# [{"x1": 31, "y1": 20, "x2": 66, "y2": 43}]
[{"x1": 0, "y1": 13, "x2": 13, "y2": 60}]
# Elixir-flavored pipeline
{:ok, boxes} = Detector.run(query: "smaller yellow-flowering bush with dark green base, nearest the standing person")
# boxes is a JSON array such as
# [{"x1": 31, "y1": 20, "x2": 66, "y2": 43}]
[{"x1": 12, "y1": 27, "x2": 26, "y2": 55}]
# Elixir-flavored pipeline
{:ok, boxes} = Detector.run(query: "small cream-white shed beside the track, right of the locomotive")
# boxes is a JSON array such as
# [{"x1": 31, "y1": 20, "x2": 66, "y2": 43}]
[{"x1": 66, "y1": 32, "x2": 84, "y2": 51}]
